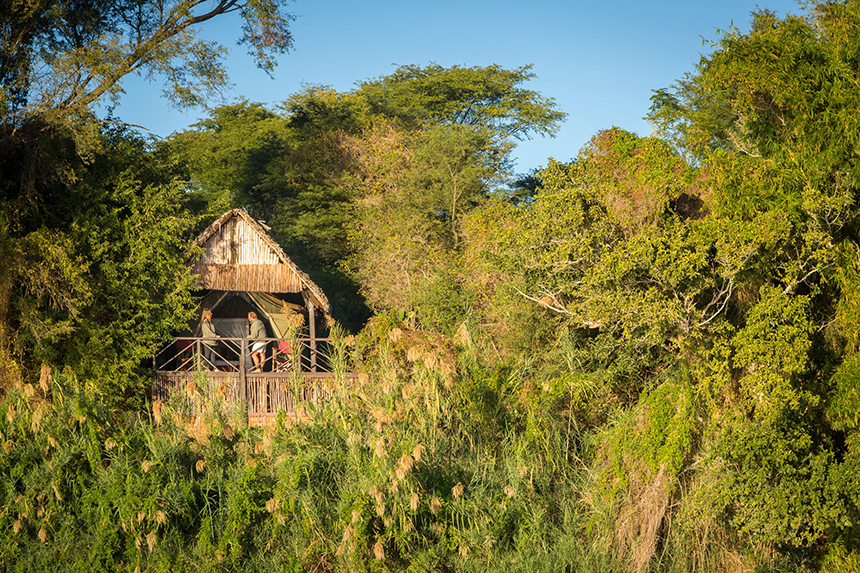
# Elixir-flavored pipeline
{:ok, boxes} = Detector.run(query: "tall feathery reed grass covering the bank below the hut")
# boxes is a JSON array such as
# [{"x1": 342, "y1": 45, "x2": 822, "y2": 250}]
[{"x1": 0, "y1": 323, "x2": 840, "y2": 572}]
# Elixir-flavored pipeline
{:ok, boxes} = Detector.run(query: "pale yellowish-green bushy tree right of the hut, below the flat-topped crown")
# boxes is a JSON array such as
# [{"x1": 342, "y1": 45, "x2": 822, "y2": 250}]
[{"x1": 350, "y1": 122, "x2": 497, "y2": 320}]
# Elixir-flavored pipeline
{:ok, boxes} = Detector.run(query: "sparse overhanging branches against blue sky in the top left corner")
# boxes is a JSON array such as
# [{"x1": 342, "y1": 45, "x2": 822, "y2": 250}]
[{"x1": 0, "y1": 0, "x2": 292, "y2": 120}]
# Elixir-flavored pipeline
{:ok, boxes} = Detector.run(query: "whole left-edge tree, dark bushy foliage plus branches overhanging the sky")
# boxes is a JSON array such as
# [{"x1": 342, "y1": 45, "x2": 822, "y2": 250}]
[{"x1": 0, "y1": 0, "x2": 292, "y2": 398}]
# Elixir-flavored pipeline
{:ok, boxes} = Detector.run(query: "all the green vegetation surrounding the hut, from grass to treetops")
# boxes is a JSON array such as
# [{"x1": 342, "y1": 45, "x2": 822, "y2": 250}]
[{"x1": 0, "y1": 1, "x2": 860, "y2": 572}]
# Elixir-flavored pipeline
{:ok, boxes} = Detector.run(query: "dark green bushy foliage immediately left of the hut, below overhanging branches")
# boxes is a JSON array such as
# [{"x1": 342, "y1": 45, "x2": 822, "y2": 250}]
[{"x1": 3, "y1": 127, "x2": 193, "y2": 401}]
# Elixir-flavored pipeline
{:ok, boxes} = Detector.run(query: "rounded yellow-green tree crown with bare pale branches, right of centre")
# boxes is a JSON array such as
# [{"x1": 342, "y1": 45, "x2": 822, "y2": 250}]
[{"x1": 470, "y1": 130, "x2": 740, "y2": 362}]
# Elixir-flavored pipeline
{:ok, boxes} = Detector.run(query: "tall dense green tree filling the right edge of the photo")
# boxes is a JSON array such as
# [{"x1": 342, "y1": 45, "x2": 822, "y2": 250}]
[{"x1": 596, "y1": 1, "x2": 860, "y2": 560}]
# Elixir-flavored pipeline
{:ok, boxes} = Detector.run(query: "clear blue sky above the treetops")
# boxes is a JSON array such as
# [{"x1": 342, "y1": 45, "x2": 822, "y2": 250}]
[{"x1": 114, "y1": 0, "x2": 801, "y2": 173}]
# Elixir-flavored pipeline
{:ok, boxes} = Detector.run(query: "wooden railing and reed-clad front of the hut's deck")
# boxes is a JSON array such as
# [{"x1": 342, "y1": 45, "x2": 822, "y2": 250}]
[{"x1": 152, "y1": 337, "x2": 353, "y2": 422}]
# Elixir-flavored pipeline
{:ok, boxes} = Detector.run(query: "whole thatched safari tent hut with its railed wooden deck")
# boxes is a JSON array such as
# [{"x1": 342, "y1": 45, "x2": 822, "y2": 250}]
[{"x1": 153, "y1": 209, "x2": 344, "y2": 422}]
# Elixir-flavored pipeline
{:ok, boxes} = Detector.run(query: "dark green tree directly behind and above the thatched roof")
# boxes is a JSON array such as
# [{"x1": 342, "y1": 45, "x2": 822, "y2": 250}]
[{"x1": 159, "y1": 88, "x2": 368, "y2": 329}]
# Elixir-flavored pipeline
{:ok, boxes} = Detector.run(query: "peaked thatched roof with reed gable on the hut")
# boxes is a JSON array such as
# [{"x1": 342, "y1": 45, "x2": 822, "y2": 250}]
[{"x1": 192, "y1": 209, "x2": 330, "y2": 314}]
